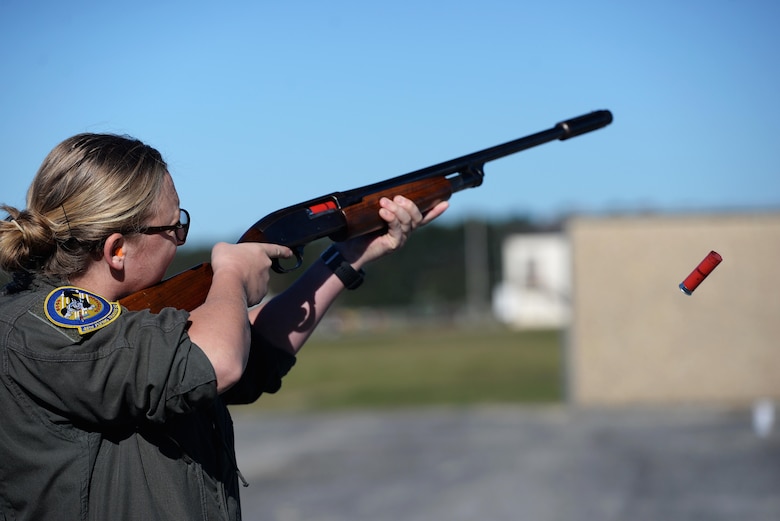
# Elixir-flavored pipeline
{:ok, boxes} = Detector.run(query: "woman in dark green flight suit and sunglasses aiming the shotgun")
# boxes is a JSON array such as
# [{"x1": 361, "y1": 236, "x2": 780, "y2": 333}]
[{"x1": 0, "y1": 134, "x2": 447, "y2": 520}]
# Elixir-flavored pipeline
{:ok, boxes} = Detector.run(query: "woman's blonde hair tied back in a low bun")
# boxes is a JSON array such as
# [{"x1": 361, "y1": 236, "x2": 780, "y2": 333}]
[{"x1": 0, "y1": 134, "x2": 168, "y2": 280}]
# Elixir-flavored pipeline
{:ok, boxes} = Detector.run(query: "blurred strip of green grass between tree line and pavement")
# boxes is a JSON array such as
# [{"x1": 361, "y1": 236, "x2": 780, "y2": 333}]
[{"x1": 241, "y1": 327, "x2": 562, "y2": 411}]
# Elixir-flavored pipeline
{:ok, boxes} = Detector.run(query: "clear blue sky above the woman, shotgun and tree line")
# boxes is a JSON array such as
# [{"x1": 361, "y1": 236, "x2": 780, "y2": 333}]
[{"x1": 0, "y1": 0, "x2": 780, "y2": 243}]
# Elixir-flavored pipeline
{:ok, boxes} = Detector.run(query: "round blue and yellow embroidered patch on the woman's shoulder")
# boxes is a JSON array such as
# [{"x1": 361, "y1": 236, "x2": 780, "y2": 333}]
[{"x1": 43, "y1": 286, "x2": 121, "y2": 335}]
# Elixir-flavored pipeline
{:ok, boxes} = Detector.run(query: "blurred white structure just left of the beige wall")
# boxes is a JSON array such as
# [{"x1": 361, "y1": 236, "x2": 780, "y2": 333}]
[{"x1": 493, "y1": 234, "x2": 571, "y2": 329}]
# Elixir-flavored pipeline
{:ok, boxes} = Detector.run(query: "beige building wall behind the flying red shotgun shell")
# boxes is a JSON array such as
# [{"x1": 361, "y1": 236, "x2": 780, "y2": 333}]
[{"x1": 566, "y1": 214, "x2": 780, "y2": 405}]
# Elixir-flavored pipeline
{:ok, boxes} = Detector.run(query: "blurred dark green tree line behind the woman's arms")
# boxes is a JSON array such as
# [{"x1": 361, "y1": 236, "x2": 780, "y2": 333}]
[{"x1": 168, "y1": 217, "x2": 562, "y2": 308}]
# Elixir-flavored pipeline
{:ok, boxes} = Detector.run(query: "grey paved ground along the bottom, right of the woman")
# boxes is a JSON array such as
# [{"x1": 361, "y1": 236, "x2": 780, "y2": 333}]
[{"x1": 234, "y1": 407, "x2": 780, "y2": 521}]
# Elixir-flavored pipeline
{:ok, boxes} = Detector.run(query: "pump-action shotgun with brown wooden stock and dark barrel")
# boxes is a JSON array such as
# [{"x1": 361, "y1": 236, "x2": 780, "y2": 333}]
[{"x1": 119, "y1": 110, "x2": 612, "y2": 313}]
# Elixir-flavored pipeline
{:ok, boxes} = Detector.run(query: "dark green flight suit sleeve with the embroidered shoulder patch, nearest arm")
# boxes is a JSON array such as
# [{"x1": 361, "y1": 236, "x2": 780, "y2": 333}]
[{"x1": 4, "y1": 309, "x2": 217, "y2": 426}]
